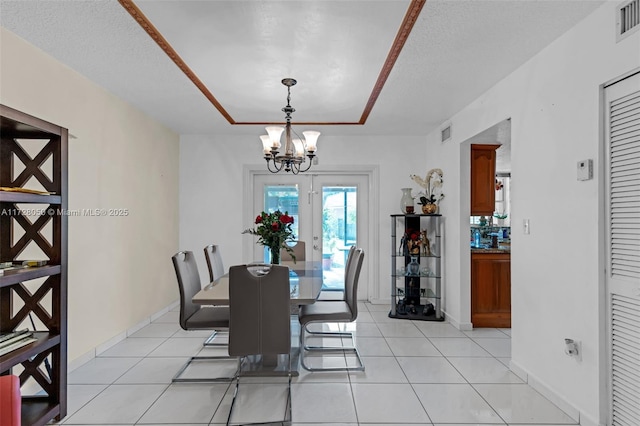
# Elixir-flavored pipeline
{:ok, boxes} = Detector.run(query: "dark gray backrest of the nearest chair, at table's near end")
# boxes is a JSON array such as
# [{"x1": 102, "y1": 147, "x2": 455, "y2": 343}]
[{"x1": 229, "y1": 265, "x2": 291, "y2": 356}]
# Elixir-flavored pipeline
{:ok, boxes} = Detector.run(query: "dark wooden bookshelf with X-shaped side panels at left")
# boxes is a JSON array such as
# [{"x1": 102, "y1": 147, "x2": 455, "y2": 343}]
[{"x1": 0, "y1": 105, "x2": 68, "y2": 426}]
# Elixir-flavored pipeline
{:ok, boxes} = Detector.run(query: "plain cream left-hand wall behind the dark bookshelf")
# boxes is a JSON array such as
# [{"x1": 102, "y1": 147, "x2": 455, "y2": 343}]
[{"x1": 0, "y1": 29, "x2": 179, "y2": 363}]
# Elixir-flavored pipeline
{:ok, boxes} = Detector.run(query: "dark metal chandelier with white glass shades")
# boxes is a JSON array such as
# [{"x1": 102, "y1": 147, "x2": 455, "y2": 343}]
[{"x1": 260, "y1": 78, "x2": 320, "y2": 175}]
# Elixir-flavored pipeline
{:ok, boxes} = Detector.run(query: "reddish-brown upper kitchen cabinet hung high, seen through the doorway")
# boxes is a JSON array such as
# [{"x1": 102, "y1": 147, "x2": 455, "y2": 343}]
[{"x1": 471, "y1": 145, "x2": 500, "y2": 216}]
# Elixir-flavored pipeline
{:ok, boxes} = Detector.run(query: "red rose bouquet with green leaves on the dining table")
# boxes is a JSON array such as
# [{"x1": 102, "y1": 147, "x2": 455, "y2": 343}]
[{"x1": 242, "y1": 210, "x2": 296, "y2": 263}]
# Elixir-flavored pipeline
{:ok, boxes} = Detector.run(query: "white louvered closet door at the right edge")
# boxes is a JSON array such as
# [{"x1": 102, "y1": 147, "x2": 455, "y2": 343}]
[{"x1": 605, "y1": 73, "x2": 640, "y2": 426}]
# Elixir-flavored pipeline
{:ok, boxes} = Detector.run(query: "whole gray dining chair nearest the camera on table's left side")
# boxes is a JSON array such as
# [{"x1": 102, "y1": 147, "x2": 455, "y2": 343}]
[{"x1": 171, "y1": 251, "x2": 235, "y2": 382}]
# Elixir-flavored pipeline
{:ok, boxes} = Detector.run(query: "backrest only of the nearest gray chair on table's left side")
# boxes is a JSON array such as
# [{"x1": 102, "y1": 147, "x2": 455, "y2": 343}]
[{"x1": 171, "y1": 251, "x2": 201, "y2": 330}]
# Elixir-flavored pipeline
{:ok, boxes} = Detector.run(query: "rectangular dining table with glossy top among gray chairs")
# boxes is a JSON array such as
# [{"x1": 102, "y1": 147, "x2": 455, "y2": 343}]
[{"x1": 191, "y1": 261, "x2": 323, "y2": 376}]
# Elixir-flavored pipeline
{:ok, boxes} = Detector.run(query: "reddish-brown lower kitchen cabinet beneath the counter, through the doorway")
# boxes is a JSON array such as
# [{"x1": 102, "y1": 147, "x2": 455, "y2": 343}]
[{"x1": 471, "y1": 252, "x2": 511, "y2": 328}]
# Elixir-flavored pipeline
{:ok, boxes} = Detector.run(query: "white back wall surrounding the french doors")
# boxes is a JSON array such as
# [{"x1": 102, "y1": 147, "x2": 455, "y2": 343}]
[{"x1": 180, "y1": 133, "x2": 427, "y2": 303}]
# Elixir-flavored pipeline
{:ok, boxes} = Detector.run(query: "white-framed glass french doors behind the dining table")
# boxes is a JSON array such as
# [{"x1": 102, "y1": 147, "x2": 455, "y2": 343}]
[{"x1": 252, "y1": 172, "x2": 369, "y2": 300}]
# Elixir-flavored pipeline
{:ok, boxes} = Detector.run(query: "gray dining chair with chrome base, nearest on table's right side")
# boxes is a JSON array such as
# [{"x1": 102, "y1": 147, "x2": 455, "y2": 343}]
[{"x1": 298, "y1": 249, "x2": 364, "y2": 371}]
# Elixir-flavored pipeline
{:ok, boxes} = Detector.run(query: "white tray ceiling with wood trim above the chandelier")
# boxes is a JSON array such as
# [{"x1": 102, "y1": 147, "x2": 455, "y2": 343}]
[{"x1": 0, "y1": 0, "x2": 603, "y2": 137}]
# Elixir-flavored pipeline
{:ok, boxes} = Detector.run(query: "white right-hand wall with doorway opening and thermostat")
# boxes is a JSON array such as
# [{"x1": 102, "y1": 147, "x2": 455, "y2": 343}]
[{"x1": 427, "y1": 1, "x2": 640, "y2": 425}]
